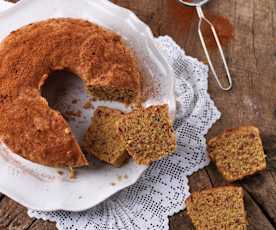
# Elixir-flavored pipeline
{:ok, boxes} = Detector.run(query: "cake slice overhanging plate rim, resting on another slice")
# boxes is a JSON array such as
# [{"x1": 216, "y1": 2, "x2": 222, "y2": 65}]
[{"x1": 118, "y1": 105, "x2": 176, "y2": 165}]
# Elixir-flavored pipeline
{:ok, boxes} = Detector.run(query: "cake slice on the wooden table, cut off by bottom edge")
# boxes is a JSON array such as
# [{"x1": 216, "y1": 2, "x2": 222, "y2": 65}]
[{"x1": 186, "y1": 186, "x2": 247, "y2": 230}]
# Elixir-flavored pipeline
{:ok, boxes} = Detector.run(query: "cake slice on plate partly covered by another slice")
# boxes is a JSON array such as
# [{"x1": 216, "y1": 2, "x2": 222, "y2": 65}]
[{"x1": 84, "y1": 107, "x2": 128, "y2": 167}]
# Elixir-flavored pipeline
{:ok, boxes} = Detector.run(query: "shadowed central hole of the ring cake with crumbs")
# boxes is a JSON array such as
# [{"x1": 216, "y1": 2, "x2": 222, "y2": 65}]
[{"x1": 41, "y1": 71, "x2": 93, "y2": 145}]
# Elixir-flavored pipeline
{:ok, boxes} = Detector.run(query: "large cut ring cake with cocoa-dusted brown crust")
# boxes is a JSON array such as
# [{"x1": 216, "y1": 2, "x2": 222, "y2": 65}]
[{"x1": 0, "y1": 18, "x2": 140, "y2": 167}]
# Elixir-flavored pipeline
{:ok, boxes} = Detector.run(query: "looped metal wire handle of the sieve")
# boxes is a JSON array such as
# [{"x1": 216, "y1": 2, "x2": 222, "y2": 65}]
[{"x1": 196, "y1": 6, "x2": 232, "y2": 91}]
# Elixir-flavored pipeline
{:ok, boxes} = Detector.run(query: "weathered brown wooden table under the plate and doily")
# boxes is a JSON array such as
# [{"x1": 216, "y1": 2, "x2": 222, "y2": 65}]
[{"x1": 0, "y1": 0, "x2": 276, "y2": 230}]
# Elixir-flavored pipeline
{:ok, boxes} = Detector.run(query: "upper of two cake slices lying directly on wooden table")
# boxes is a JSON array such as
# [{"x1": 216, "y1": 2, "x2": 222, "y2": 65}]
[{"x1": 208, "y1": 126, "x2": 266, "y2": 181}]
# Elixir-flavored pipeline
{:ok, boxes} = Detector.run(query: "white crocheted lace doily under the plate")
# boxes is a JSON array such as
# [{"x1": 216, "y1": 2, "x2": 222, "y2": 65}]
[{"x1": 24, "y1": 36, "x2": 220, "y2": 230}]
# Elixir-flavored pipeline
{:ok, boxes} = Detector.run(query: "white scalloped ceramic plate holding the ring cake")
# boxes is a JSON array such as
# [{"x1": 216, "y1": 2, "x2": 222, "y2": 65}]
[{"x1": 0, "y1": 0, "x2": 175, "y2": 211}]
